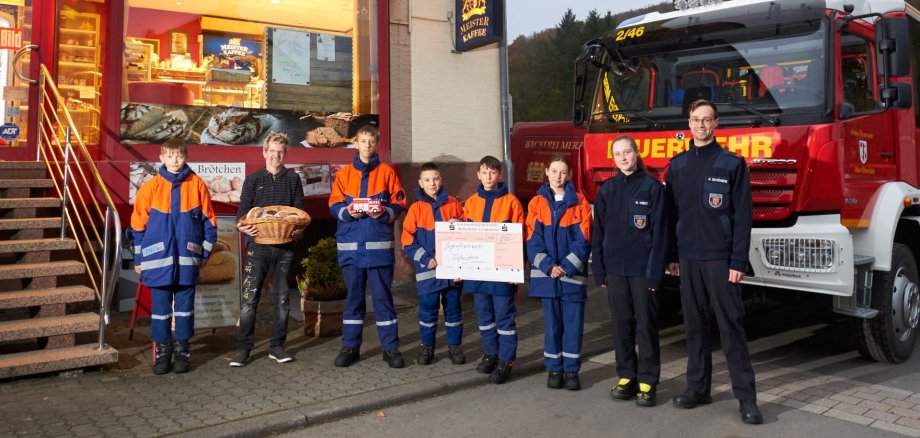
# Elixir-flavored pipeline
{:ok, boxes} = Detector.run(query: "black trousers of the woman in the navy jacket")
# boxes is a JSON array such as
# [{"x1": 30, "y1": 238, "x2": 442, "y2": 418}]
[{"x1": 607, "y1": 275, "x2": 656, "y2": 385}]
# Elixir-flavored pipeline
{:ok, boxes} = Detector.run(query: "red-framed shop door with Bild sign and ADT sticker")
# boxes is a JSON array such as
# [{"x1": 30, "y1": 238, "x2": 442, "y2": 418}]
[{"x1": 0, "y1": 0, "x2": 56, "y2": 161}]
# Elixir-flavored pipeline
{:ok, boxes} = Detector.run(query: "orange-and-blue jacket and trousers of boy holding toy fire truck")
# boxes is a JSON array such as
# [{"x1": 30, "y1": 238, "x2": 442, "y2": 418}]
[{"x1": 329, "y1": 154, "x2": 406, "y2": 351}]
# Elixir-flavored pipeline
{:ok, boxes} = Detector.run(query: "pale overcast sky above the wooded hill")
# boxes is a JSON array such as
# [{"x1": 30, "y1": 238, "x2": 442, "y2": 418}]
[{"x1": 507, "y1": 0, "x2": 662, "y2": 42}]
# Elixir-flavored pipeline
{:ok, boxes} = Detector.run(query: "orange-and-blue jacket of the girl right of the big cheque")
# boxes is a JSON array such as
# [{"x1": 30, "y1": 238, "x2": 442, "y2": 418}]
[{"x1": 527, "y1": 183, "x2": 591, "y2": 301}]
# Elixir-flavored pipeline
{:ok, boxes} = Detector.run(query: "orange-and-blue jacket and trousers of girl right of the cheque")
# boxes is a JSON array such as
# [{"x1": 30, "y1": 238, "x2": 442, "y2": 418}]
[{"x1": 527, "y1": 182, "x2": 591, "y2": 373}]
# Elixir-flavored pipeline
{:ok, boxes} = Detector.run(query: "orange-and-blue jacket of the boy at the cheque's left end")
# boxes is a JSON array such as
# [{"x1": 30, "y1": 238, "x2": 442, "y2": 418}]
[{"x1": 402, "y1": 188, "x2": 463, "y2": 294}]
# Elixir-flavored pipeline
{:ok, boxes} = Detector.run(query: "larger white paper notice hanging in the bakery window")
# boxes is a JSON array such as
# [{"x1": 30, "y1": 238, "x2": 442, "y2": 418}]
[{"x1": 269, "y1": 28, "x2": 312, "y2": 85}]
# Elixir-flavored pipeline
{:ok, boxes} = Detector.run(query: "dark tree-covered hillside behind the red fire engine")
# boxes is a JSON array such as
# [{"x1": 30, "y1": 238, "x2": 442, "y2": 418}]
[{"x1": 508, "y1": 2, "x2": 674, "y2": 122}]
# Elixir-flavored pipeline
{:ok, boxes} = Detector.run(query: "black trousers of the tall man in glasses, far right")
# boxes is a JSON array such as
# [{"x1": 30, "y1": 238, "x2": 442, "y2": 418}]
[{"x1": 680, "y1": 258, "x2": 757, "y2": 401}]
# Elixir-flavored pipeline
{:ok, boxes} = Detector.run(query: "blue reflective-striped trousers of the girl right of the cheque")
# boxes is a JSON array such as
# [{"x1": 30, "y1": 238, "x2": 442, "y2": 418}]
[{"x1": 541, "y1": 298, "x2": 585, "y2": 373}]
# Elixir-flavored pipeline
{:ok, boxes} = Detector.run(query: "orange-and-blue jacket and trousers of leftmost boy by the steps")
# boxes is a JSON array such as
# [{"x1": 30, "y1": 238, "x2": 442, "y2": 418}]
[{"x1": 128, "y1": 165, "x2": 217, "y2": 344}]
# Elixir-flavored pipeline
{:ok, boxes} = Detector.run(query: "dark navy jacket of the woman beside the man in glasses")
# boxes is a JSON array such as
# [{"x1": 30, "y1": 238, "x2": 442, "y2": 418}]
[{"x1": 593, "y1": 170, "x2": 668, "y2": 289}]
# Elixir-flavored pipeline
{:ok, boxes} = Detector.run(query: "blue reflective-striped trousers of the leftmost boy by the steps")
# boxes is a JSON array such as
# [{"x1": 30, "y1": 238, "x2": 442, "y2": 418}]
[{"x1": 150, "y1": 286, "x2": 195, "y2": 344}]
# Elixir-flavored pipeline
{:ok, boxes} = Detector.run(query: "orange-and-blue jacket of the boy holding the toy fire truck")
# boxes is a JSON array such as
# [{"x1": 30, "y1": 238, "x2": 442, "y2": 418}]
[{"x1": 329, "y1": 154, "x2": 406, "y2": 268}]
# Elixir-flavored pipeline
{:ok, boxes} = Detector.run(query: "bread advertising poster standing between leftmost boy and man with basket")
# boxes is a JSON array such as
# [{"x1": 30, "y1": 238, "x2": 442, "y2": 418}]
[{"x1": 195, "y1": 216, "x2": 240, "y2": 329}]
